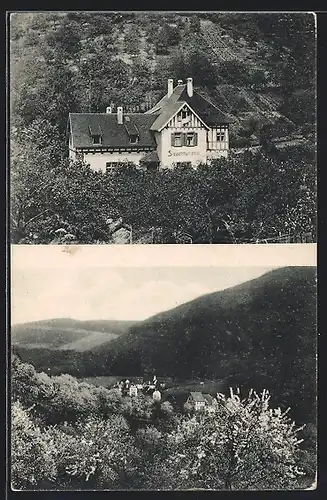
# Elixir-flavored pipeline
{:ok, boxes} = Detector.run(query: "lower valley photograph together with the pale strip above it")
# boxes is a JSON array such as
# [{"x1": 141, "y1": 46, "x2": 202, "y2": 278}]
[{"x1": 10, "y1": 245, "x2": 317, "y2": 491}]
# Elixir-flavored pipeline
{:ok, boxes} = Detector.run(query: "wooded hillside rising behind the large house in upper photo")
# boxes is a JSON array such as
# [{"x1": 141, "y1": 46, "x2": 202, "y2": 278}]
[{"x1": 10, "y1": 12, "x2": 315, "y2": 147}]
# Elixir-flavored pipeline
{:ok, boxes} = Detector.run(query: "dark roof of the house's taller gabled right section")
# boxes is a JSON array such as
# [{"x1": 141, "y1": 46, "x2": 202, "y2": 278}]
[{"x1": 146, "y1": 84, "x2": 231, "y2": 130}]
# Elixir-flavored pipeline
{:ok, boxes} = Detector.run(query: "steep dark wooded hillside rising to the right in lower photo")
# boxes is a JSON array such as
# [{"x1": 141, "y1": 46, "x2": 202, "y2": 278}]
[{"x1": 98, "y1": 267, "x2": 315, "y2": 378}]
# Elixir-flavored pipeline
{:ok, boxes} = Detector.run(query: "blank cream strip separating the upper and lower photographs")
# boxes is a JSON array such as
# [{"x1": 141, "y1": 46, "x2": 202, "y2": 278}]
[{"x1": 10, "y1": 243, "x2": 317, "y2": 269}]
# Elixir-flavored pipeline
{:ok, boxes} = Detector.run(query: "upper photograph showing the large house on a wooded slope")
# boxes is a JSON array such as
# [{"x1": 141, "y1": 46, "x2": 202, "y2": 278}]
[{"x1": 7, "y1": 10, "x2": 317, "y2": 245}]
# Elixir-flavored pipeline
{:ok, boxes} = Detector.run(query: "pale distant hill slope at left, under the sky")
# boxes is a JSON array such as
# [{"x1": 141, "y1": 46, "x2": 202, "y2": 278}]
[{"x1": 11, "y1": 318, "x2": 133, "y2": 351}]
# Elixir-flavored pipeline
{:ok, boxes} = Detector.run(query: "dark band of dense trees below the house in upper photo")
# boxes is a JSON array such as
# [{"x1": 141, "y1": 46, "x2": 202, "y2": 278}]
[{"x1": 11, "y1": 144, "x2": 316, "y2": 243}]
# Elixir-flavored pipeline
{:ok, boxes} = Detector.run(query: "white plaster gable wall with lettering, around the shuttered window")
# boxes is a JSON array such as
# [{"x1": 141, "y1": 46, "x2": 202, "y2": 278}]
[{"x1": 161, "y1": 128, "x2": 207, "y2": 167}]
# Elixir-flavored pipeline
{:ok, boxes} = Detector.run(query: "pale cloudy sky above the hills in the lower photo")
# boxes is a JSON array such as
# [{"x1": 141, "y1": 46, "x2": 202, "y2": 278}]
[{"x1": 11, "y1": 263, "x2": 278, "y2": 324}]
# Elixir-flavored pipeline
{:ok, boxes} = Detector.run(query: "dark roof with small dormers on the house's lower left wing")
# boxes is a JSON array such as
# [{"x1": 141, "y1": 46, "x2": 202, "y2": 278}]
[{"x1": 69, "y1": 113, "x2": 157, "y2": 148}]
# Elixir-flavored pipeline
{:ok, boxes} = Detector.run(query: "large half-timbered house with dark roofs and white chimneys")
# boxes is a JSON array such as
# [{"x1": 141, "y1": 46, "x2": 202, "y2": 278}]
[{"x1": 67, "y1": 78, "x2": 229, "y2": 170}]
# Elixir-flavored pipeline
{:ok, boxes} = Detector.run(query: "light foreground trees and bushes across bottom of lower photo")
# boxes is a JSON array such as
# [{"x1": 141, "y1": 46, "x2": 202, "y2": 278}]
[{"x1": 11, "y1": 356, "x2": 315, "y2": 490}]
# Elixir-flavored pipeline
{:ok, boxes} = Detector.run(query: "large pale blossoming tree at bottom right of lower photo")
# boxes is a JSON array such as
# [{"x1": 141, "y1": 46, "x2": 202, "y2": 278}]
[{"x1": 163, "y1": 390, "x2": 308, "y2": 490}]
